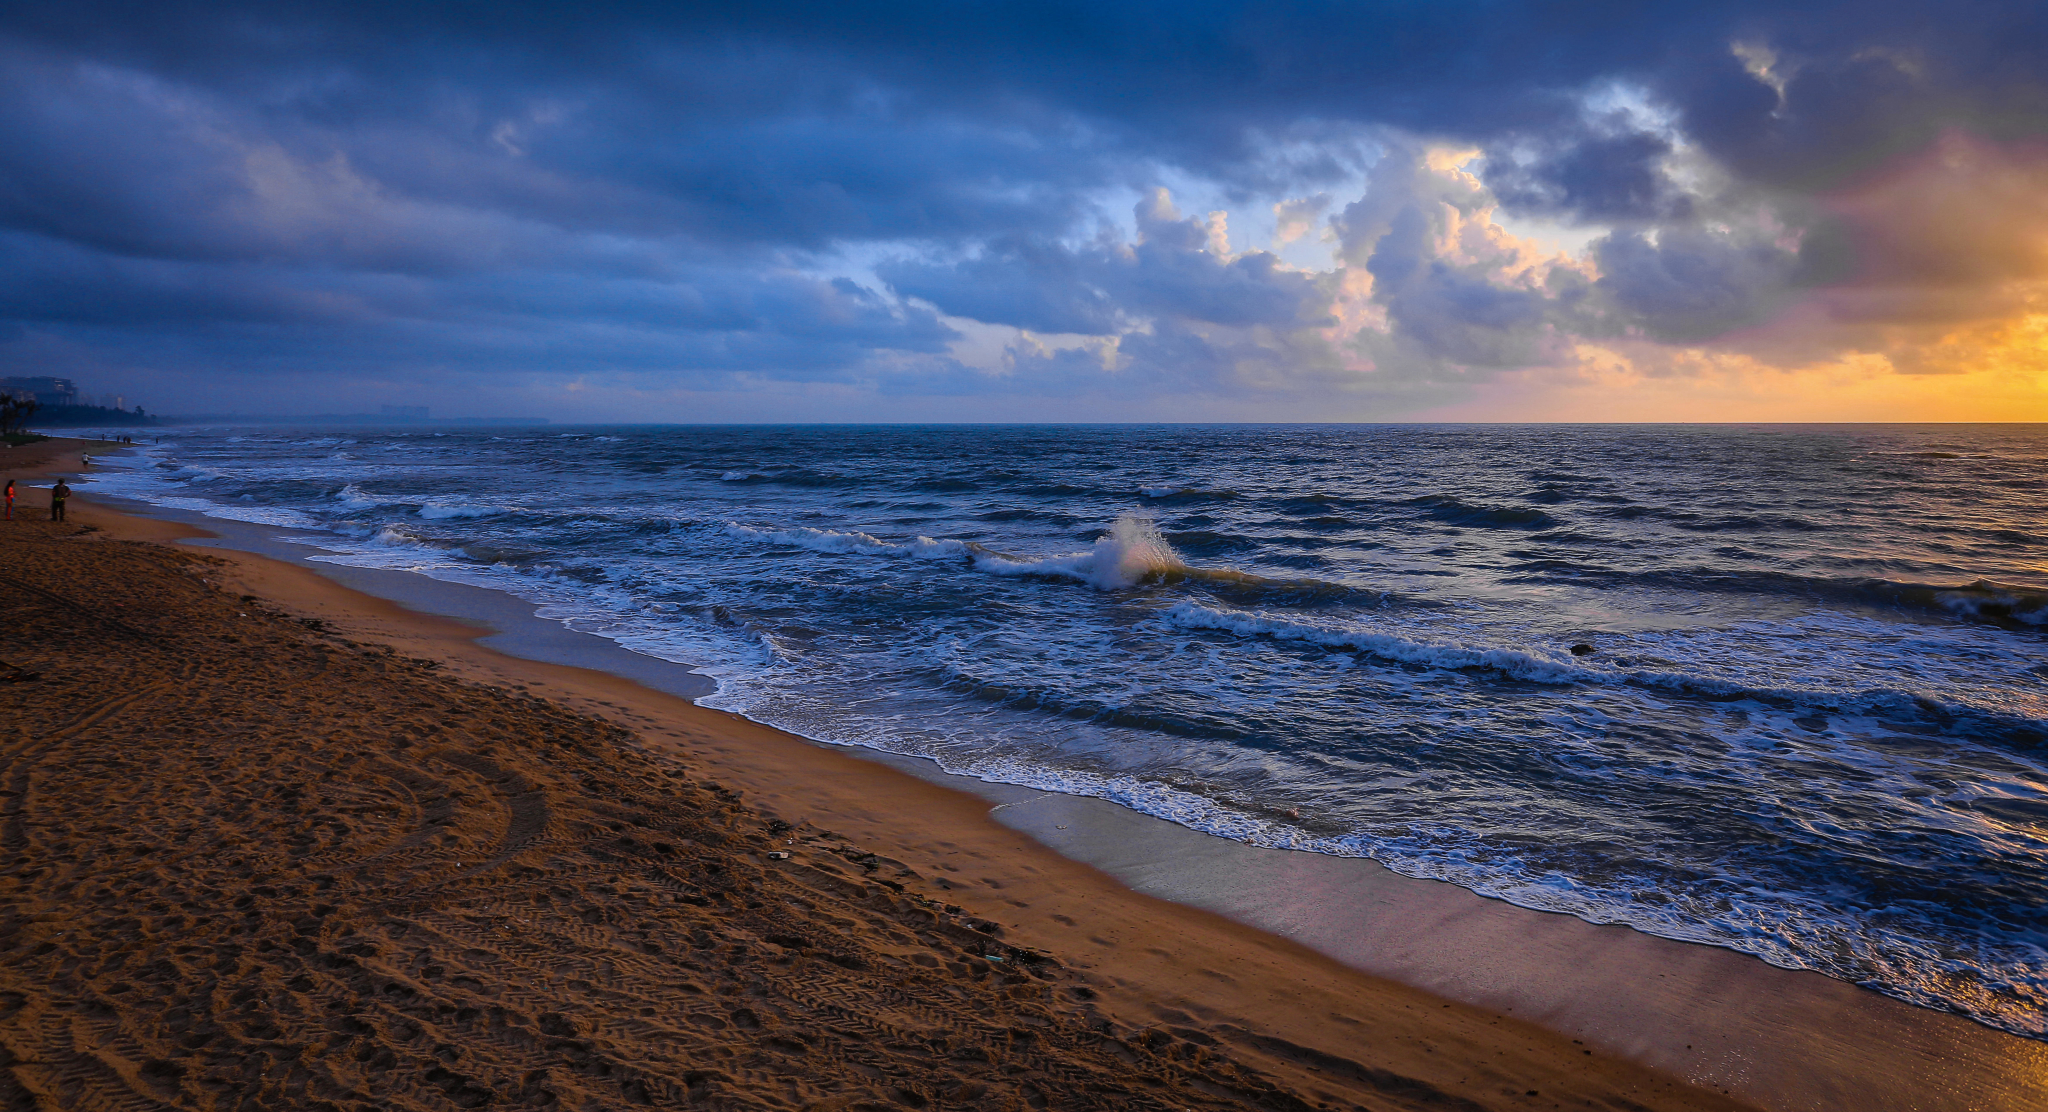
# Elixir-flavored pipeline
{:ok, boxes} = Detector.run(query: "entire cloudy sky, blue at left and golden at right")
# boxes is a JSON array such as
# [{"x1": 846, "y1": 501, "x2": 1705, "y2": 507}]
[{"x1": 0, "y1": 0, "x2": 2048, "y2": 422}]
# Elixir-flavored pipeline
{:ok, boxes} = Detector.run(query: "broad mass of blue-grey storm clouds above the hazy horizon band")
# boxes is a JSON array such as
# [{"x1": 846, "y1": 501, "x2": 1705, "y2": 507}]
[{"x1": 0, "y1": 0, "x2": 2048, "y2": 411}]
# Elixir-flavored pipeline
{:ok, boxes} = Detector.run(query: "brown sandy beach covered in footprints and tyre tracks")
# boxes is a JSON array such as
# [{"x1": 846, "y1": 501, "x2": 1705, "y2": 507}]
[{"x1": 0, "y1": 442, "x2": 2032, "y2": 1108}]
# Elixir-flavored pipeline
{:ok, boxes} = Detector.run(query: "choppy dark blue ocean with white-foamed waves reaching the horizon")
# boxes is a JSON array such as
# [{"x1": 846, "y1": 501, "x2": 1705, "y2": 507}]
[{"x1": 82, "y1": 426, "x2": 2048, "y2": 1038}]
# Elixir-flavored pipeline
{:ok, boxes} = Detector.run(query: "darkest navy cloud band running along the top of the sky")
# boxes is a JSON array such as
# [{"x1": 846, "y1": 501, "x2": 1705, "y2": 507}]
[{"x1": 10, "y1": 0, "x2": 2048, "y2": 170}]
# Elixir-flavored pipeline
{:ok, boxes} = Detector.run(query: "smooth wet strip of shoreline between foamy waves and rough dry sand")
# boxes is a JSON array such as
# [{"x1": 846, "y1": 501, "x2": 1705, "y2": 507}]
[{"x1": 19, "y1": 440, "x2": 2048, "y2": 1110}]
